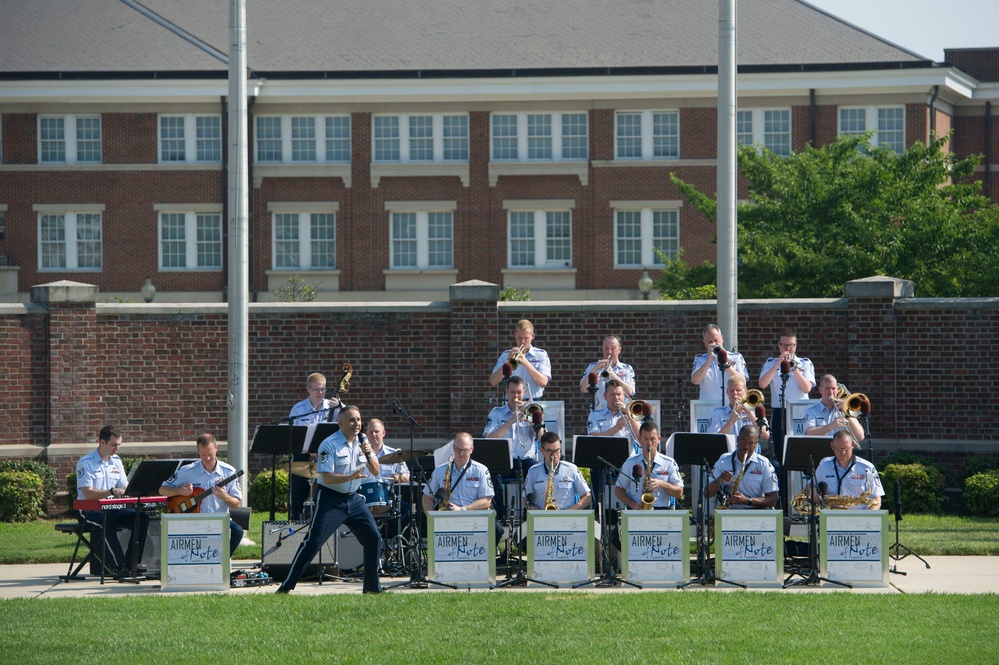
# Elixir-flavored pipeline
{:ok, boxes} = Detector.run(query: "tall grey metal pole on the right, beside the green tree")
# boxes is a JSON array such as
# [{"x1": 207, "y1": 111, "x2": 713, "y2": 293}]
[{"x1": 716, "y1": 0, "x2": 739, "y2": 349}]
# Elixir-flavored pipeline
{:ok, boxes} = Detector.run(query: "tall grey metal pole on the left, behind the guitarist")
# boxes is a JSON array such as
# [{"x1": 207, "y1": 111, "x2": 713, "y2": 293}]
[{"x1": 227, "y1": 0, "x2": 249, "y2": 498}]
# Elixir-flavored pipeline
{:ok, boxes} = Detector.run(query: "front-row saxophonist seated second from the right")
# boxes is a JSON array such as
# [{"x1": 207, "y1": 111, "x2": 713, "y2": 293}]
[{"x1": 708, "y1": 425, "x2": 778, "y2": 509}]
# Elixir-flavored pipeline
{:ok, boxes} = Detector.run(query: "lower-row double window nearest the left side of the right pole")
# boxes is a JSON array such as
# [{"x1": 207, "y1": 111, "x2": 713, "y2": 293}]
[{"x1": 614, "y1": 208, "x2": 680, "y2": 268}]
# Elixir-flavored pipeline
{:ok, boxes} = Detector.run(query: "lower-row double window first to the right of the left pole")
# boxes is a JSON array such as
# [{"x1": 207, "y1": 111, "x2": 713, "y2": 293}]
[{"x1": 272, "y1": 212, "x2": 336, "y2": 270}]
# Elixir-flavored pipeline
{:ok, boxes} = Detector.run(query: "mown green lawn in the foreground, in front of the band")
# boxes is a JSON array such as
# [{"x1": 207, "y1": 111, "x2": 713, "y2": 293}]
[{"x1": 0, "y1": 591, "x2": 999, "y2": 665}]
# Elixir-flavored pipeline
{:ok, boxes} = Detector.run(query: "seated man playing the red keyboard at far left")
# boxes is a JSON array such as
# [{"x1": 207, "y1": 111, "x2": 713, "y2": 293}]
[{"x1": 76, "y1": 425, "x2": 149, "y2": 577}]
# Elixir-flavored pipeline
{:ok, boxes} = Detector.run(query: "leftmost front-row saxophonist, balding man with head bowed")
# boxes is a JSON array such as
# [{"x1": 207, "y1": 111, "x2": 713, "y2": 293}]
[{"x1": 421, "y1": 432, "x2": 503, "y2": 542}]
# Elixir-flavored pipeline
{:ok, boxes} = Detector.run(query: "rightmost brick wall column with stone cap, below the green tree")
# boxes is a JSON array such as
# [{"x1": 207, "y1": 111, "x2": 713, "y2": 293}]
[{"x1": 844, "y1": 275, "x2": 913, "y2": 448}]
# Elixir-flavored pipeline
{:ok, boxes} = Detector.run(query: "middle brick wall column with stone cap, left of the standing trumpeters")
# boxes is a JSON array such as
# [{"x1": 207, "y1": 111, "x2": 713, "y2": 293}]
[{"x1": 449, "y1": 280, "x2": 499, "y2": 436}]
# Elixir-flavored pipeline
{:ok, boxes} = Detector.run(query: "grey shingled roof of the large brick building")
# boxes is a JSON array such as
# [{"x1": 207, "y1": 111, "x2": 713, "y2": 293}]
[{"x1": 0, "y1": 0, "x2": 933, "y2": 77}]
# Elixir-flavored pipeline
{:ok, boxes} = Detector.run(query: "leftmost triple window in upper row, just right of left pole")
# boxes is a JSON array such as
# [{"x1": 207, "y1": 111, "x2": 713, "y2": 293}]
[{"x1": 256, "y1": 115, "x2": 350, "y2": 164}]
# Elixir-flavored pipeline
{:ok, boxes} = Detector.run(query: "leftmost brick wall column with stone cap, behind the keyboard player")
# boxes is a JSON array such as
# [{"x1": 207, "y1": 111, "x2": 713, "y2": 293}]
[{"x1": 31, "y1": 280, "x2": 103, "y2": 443}]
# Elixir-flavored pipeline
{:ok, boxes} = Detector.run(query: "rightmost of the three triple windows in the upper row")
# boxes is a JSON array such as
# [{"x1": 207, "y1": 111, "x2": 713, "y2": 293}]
[{"x1": 490, "y1": 113, "x2": 589, "y2": 162}]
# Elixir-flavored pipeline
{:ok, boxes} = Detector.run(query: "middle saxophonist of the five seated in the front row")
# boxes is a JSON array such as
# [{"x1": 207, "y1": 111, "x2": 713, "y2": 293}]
[{"x1": 614, "y1": 421, "x2": 683, "y2": 510}]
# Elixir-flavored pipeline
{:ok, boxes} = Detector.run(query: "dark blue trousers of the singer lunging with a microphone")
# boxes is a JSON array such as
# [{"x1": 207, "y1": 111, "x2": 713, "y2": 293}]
[{"x1": 281, "y1": 485, "x2": 382, "y2": 592}]
